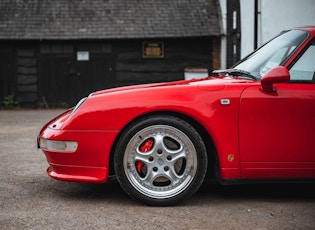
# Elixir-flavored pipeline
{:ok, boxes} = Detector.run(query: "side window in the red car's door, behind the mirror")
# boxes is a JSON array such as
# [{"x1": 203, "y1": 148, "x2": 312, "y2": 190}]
[{"x1": 290, "y1": 41, "x2": 315, "y2": 81}]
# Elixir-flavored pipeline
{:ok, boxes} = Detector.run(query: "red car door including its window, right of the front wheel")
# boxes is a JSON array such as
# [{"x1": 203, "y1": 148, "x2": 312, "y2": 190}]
[{"x1": 239, "y1": 42, "x2": 315, "y2": 178}]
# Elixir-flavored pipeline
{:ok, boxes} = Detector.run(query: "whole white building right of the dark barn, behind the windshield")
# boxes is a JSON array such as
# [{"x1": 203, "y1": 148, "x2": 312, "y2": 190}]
[{"x1": 220, "y1": 0, "x2": 315, "y2": 68}]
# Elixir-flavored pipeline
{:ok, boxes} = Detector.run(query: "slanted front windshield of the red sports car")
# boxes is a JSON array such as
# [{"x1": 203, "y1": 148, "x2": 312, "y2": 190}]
[{"x1": 232, "y1": 30, "x2": 308, "y2": 78}]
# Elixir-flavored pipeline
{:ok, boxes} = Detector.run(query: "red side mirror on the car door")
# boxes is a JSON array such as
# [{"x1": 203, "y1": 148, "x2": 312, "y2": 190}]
[{"x1": 261, "y1": 66, "x2": 290, "y2": 93}]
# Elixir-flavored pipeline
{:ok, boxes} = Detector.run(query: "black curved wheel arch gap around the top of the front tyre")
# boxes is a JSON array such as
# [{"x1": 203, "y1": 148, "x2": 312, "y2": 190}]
[{"x1": 109, "y1": 111, "x2": 219, "y2": 180}]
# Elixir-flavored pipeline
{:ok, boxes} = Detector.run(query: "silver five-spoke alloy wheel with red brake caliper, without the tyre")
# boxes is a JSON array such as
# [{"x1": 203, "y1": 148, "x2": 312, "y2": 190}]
[{"x1": 123, "y1": 125, "x2": 197, "y2": 199}]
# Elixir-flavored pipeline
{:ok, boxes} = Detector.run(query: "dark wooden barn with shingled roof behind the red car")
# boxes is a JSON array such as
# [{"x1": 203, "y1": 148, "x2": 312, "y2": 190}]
[{"x1": 0, "y1": 0, "x2": 221, "y2": 107}]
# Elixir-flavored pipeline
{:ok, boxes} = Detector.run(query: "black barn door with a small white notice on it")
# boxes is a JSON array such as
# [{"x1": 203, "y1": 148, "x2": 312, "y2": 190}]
[{"x1": 38, "y1": 42, "x2": 115, "y2": 106}]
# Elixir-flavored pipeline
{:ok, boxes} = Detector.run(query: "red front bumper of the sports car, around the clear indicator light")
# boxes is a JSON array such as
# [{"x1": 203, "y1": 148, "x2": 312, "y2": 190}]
[{"x1": 37, "y1": 111, "x2": 118, "y2": 183}]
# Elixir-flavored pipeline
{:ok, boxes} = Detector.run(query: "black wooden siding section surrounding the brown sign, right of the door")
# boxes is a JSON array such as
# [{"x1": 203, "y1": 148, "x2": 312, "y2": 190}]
[{"x1": 115, "y1": 38, "x2": 212, "y2": 86}]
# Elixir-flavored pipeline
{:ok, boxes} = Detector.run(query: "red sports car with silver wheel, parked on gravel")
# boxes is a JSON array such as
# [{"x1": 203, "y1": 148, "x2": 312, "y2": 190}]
[{"x1": 38, "y1": 26, "x2": 315, "y2": 205}]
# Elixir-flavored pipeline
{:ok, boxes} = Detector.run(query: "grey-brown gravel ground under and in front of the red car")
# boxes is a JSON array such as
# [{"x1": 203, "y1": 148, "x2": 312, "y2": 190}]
[{"x1": 0, "y1": 110, "x2": 315, "y2": 230}]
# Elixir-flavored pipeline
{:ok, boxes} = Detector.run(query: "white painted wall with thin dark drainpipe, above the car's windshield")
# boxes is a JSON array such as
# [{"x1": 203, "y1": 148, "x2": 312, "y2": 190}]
[{"x1": 240, "y1": 0, "x2": 315, "y2": 58}]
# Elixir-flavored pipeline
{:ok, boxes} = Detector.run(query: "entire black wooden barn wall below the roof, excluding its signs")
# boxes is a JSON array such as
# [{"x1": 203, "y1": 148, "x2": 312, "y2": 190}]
[{"x1": 0, "y1": 37, "x2": 220, "y2": 107}]
